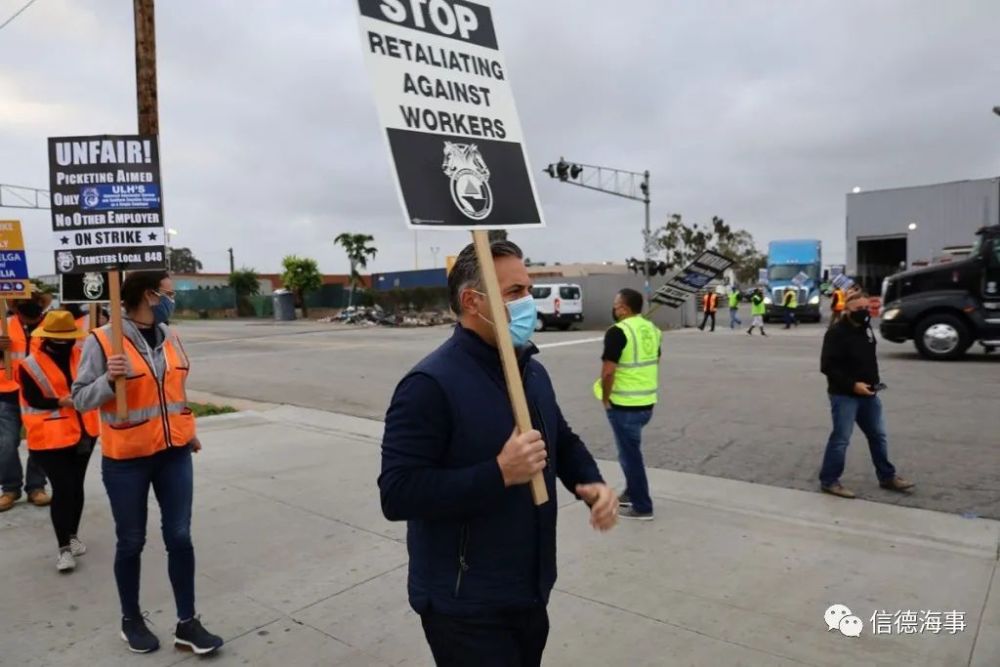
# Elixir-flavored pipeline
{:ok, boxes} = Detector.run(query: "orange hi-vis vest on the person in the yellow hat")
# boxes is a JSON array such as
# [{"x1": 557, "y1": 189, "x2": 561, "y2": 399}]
[{"x1": 21, "y1": 348, "x2": 101, "y2": 451}]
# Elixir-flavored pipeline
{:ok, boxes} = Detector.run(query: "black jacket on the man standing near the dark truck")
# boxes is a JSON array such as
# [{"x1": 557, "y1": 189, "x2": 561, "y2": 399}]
[{"x1": 820, "y1": 317, "x2": 879, "y2": 396}]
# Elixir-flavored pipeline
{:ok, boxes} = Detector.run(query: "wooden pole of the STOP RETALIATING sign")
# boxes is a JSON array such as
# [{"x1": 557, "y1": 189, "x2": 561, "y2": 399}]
[{"x1": 472, "y1": 230, "x2": 555, "y2": 505}]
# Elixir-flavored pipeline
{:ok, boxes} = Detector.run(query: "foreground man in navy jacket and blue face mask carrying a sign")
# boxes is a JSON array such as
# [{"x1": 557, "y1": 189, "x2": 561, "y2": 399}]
[{"x1": 378, "y1": 241, "x2": 618, "y2": 667}]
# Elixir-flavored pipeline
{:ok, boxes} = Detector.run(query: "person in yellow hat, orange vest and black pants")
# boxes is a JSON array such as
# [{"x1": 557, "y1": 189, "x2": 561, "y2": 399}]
[{"x1": 20, "y1": 310, "x2": 101, "y2": 572}]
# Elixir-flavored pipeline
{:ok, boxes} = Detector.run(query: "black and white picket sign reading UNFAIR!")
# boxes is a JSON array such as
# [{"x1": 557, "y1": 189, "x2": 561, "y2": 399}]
[{"x1": 49, "y1": 135, "x2": 166, "y2": 274}]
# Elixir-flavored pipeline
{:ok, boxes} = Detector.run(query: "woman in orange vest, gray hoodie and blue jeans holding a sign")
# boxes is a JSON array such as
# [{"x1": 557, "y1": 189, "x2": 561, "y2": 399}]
[{"x1": 73, "y1": 271, "x2": 222, "y2": 655}]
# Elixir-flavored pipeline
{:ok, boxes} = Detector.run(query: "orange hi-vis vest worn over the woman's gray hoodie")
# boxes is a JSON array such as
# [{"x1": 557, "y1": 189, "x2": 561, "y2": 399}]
[{"x1": 93, "y1": 327, "x2": 195, "y2": 459}]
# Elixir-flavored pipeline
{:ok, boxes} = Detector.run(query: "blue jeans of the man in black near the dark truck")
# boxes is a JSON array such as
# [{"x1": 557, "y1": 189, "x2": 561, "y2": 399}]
[{"x1": 819, "y1": 394, "x2": 896, "y2": 486}]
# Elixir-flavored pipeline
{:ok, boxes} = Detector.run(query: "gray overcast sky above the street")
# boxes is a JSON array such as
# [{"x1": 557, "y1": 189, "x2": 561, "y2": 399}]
[{"x1": 0, "y1": 0, "x2": 1000, "y2": 273}]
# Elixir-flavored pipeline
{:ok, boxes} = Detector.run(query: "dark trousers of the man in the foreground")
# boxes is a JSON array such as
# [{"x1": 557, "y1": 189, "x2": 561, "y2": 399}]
[{"x1": 420, "y1": 607, "x2": 549, "y2": 667}]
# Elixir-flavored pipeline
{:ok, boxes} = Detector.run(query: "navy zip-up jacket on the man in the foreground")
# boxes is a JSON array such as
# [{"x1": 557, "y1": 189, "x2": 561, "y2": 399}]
[{"x1": 378, "y1": 326, "x2": 601, "y2": 616}]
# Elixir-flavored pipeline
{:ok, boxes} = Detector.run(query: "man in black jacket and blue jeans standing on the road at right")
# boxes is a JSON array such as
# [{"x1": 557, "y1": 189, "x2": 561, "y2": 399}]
[{"x1": 819, "y1": 292, "x2": 913, "y2": 498}]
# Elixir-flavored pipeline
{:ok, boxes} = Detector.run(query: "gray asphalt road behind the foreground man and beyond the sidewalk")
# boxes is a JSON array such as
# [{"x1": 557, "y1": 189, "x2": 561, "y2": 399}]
[{"x1": 180, "y1": 314, "x2": 1000, "y2": 518}]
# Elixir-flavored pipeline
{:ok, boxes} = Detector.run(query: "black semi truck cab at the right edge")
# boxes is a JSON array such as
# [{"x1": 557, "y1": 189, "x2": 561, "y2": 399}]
[{"x1": 879, "y1": 225, "x2": 1000, "y2": 360}]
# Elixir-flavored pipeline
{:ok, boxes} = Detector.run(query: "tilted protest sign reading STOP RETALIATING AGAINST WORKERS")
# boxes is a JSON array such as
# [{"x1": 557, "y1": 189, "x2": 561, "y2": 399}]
[{"x1": 358, "y1": 0, "x2": 543, "y2": 229}]
